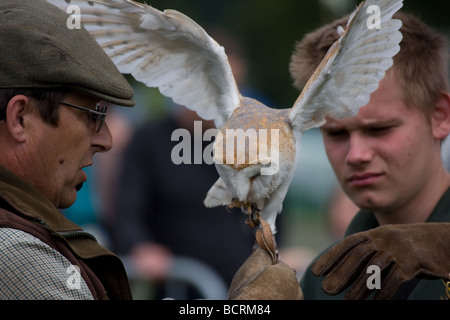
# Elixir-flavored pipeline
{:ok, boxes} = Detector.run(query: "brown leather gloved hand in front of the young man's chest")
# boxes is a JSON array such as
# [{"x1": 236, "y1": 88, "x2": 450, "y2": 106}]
[{"x1": 312, "y1": 223, "x2": 450, "y2": 299}]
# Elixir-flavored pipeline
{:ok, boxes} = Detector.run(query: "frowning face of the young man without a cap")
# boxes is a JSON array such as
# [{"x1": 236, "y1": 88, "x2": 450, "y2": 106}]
[{"x1": 321, "y1": 73, "x2": 440, "y2": 218}]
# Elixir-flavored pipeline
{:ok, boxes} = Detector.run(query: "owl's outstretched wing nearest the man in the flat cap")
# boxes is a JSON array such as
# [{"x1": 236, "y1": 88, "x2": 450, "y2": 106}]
[{"x1": 47, "y1": 0, "x2": 241, "y2": 128}]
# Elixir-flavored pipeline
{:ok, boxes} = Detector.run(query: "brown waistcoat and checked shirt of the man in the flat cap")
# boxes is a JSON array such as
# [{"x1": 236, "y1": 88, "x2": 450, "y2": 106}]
[{"x1": 0, "y1": 166, "x2": 132, "y2": 299}]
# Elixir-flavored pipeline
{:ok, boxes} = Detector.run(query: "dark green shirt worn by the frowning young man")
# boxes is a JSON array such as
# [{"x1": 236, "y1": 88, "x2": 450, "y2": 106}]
[{"x1": 300, "y1": 188, "x2": 450, "y2": 300}]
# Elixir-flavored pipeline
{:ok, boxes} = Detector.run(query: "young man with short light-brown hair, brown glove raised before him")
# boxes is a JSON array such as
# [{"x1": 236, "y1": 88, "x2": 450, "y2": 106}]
[{"x1": 290, "y1": 13, "x2": 450, "y2": 299}]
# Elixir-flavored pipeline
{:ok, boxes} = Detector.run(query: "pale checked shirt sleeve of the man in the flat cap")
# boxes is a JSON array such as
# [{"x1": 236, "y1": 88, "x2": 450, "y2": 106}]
[{"x1": 0, "y1": 228, "x2": 93, "y2": 300}]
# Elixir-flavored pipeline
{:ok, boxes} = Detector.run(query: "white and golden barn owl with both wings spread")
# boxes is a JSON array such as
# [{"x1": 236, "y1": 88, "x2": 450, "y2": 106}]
[{"x1": 48, "y1": 0, "x2": 403, "y2": 252}]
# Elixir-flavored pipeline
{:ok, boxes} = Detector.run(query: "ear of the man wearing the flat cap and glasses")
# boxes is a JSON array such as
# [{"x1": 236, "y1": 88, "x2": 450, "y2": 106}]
[{"x1": 6, "y1": 95, "x2": 31, "y2": 143}]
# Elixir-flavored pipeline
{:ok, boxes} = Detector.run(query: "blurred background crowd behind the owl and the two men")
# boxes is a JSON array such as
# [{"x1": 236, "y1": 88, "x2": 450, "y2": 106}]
[{"x1": 64, "y1": 0, "x2": 450, "y2": 299}]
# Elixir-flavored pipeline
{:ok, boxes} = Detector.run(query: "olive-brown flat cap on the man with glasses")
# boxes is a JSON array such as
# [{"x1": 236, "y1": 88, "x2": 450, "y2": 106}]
[{"x1": 0, "y1": 0, "x2": 135, "y2": 107}]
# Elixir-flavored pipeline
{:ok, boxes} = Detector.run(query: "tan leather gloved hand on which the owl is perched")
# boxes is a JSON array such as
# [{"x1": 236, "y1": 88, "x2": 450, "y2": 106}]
[{"x1": 228, "y1": 220, "x2": 303, "y2": 300}]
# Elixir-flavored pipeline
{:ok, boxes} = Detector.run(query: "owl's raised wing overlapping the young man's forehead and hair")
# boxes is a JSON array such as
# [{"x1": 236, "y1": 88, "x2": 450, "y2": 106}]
[{"x1": 289, "y1": 0, "x2": 403, "y2": 131}]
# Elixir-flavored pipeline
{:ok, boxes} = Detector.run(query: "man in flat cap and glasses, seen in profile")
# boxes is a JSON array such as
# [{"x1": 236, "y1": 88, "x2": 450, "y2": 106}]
[{"x1": 0, "y1": 0, "x2": 134, "y2": 299}]
